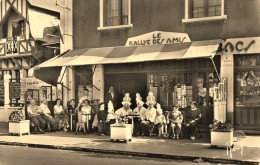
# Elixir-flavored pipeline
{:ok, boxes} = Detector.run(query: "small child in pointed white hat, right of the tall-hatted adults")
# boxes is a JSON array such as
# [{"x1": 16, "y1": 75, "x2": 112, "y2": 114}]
[{"x1": 154, "y1": 103, "x2": 166, "y2": 138}]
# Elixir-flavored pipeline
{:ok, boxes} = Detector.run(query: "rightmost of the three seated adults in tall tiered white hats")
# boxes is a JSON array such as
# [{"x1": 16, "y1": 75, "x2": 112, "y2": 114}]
[{"x1": 141, "y1": 92, "x2": 156, "y2": 136}]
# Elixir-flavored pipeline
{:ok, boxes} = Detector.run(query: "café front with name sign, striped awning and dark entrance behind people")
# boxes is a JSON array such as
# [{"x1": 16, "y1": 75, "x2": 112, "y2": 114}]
[{"x1": 38, "y1": 31, "x2": 220, "y2": 127}]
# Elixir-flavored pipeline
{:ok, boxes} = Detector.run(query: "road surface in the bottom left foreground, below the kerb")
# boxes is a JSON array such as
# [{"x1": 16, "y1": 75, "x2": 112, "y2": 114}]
[{"x1": 0, "y1": 146, "x2": 215, "y2": 165}]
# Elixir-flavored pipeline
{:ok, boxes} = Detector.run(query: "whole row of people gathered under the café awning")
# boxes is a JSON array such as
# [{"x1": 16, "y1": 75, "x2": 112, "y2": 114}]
[{"x1": 27, "y1": 88, "x2": 202, "y2": 140}]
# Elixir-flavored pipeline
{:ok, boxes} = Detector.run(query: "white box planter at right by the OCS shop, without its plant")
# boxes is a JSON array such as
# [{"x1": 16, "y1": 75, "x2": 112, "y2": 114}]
[{"x1": 211, "y1": 129, "x2": 234, "y2": 147}]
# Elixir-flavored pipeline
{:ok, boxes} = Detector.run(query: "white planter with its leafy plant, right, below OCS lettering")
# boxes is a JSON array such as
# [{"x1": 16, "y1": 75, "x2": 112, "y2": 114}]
[{"x1": 209, "y1": 120, "x2": 234, "y2": 147}]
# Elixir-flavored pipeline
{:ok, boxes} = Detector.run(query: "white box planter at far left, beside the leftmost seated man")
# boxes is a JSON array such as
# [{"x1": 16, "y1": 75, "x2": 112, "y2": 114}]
[{"x1": 9, "y1": 120, "x2": 30, "y2": 136}]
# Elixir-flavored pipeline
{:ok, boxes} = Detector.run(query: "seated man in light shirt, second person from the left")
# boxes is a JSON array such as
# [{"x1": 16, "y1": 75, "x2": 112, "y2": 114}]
[{"x1": 40, "y1": 99, "x2": 59, "y2": 132}]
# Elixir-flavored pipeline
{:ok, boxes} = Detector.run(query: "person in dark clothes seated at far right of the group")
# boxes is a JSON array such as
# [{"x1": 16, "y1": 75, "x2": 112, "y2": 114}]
[{"x1": 186, "y1": 101, "x2": 202, "y2": 140}]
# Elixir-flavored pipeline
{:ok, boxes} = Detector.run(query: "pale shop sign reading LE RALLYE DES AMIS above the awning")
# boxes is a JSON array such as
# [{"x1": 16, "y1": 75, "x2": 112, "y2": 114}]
[{"x1": 126, "y1": 31, "x2": 191, "y2": 46}]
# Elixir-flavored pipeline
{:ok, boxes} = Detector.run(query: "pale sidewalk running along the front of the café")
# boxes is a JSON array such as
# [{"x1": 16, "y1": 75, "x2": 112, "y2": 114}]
[{"x1": 0, "y1": 124, "x2": 260, "y2": 164}]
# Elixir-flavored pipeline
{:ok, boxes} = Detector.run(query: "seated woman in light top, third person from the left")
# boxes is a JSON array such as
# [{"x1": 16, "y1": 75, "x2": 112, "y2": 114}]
[{"x1": 53, "y1": 99, "x2": 69, "y2": 131}]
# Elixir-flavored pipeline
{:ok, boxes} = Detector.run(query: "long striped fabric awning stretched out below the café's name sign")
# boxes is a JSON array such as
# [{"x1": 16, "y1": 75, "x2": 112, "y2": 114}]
[{"x1": 37, "y1": 40, "x2": 220, "y2": 68}]
